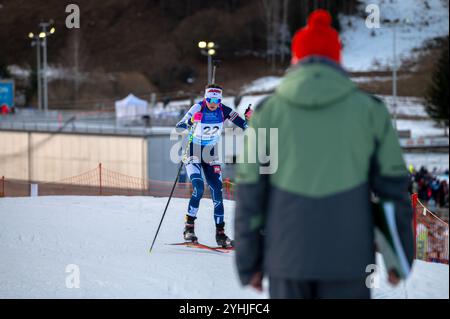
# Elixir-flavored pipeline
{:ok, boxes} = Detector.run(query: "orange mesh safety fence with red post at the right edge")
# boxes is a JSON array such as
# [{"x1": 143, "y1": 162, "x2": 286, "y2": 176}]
[{"x1": 412, "y1": 194, "x2": 449, "y2": 265}]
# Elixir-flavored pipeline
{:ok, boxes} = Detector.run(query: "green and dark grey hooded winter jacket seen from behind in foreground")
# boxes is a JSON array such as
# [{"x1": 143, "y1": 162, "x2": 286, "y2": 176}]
[{"x1": 235, "y1": 58, "x2": 413, "y2": 284}]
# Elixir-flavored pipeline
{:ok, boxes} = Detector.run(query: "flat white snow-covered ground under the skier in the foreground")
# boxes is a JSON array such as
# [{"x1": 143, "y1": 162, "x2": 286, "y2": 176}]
[{"x1": 0, "y1": 196, "x2": 449, "y2": 299}]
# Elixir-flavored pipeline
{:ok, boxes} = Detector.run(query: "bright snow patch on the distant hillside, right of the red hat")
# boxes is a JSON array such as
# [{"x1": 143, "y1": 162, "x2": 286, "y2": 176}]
[{"x1": 341, "y1": 0, "x2": 449, "y2": 71}]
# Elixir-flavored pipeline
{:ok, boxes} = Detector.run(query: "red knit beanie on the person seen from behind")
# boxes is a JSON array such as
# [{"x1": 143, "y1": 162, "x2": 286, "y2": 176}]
[{"x1": 291, "y1": 9, "x2": 342, "y2": 64}]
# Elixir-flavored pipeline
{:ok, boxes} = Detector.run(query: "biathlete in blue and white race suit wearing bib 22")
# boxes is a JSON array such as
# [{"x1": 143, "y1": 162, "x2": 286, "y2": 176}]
[{"x1": 176, "y1": 84, "x2": 252, "y2": 248}]
